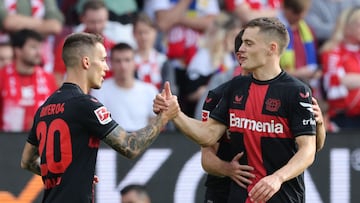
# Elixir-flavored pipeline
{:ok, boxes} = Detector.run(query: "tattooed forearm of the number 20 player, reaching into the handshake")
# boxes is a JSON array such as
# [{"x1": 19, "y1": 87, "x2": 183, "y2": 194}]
[{"x1": 104, "y1": 115, "x2": 163, "y2": 158}]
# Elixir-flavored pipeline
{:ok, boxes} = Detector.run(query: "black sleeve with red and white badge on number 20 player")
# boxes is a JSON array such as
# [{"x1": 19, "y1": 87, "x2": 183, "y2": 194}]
[{"x1": 82, "y1": 95, "x2": 118, "y2": 139}]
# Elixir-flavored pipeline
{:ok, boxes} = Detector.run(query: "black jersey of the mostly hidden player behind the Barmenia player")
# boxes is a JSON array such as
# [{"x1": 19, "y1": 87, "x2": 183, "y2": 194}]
[{"x1": 202, "y1": 82, "x2": 234, "y2": 202}]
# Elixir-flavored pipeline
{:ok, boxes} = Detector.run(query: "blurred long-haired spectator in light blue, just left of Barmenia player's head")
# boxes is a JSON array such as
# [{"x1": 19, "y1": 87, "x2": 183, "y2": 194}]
[{"x1": 185, "y1": 16, "x2": 241, "y2": 116}]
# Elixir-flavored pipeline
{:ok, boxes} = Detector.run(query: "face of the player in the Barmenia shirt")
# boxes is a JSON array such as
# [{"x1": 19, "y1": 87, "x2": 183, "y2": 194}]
[{"x1": 236, "y1": 27, "x2": 267, "y2": 71}]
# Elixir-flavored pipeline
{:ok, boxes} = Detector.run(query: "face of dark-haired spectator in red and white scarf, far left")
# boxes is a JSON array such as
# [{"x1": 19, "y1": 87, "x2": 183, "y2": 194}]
[{"x1": 15, "y1": 39, "x2": 42, "y2": 66}]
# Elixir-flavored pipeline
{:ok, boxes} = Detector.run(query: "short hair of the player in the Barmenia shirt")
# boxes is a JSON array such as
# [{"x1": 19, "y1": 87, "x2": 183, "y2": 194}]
[{"x1": 244, "y1": 17, "x2": 290, "y2": 54}]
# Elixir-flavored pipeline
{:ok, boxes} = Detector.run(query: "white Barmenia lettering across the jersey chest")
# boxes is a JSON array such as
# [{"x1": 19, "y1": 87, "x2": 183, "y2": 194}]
[{"x1": 230, "y1": 113, "x2": 284, "y2": 133}]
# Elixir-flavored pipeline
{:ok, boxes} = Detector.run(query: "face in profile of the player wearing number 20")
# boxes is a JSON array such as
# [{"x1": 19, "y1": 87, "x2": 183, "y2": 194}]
[{"x1": 89, "y1": 43, "x2": 109, "y2": 89}]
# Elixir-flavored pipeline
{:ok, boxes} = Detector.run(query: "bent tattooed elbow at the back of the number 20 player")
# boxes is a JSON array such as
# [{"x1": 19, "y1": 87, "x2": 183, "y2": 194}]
[{"x1": 21, "y1": 142, "x2": 41, "y2": 175}]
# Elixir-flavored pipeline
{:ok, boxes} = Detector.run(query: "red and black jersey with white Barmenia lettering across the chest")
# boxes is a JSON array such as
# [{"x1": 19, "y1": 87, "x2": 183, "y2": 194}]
[{"x1": 210, "y1": 72, "x2": 316, "y2": 203}]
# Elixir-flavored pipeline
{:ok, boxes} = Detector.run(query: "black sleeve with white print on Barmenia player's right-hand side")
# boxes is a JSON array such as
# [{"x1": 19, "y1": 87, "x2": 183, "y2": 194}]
[{"x1": 289, "y1": 85, "x2": 316, "y2": 137}]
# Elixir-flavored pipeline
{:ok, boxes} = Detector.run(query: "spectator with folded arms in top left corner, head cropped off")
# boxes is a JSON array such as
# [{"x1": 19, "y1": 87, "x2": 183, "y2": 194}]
[{"x1": 0, "y1": 0, "x2": 64, "y2": 72}]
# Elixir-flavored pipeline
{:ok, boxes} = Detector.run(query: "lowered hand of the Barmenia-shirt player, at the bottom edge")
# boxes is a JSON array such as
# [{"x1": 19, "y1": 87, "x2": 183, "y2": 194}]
[{"x1": 249, "y1": 174, "x2": 282, "y2": 202}]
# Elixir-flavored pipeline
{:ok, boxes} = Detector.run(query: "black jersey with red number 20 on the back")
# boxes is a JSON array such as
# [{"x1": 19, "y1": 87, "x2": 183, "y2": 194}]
[{"x1": 27, "y1": 83, "x2": 118, "y2": 203}]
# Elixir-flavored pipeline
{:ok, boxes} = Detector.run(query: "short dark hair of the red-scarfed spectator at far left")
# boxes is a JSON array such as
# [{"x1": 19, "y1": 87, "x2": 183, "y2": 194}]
[{"x1": 10, "y1": 29, "x2": 44, "y2": 48}]
